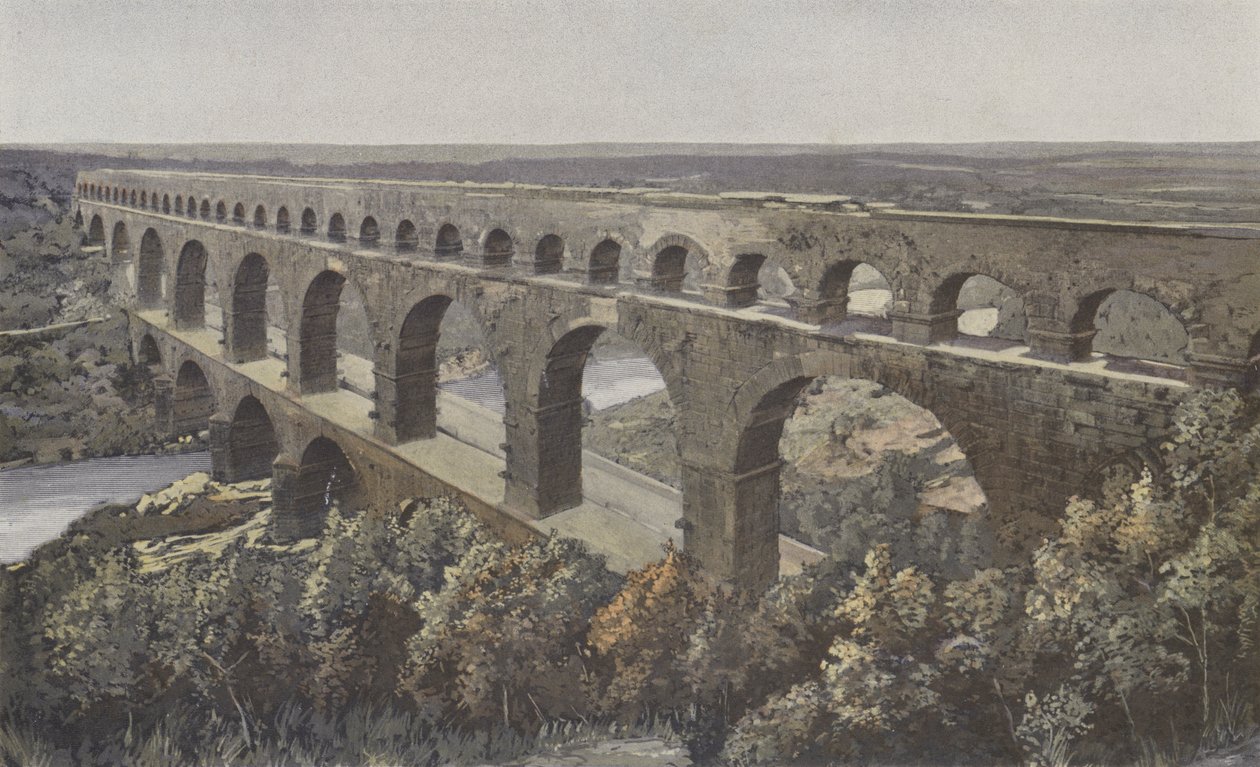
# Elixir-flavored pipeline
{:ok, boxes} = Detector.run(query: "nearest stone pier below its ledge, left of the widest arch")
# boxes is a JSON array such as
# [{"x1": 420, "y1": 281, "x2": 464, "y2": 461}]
[{"x1": 683, "y1": 460, "x2": 782, "y2": 587}]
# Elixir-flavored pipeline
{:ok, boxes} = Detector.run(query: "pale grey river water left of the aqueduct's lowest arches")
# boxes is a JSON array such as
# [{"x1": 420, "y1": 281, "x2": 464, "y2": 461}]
[{"x1": 0, "y1": 452, "x2": 210, "y2": 563}]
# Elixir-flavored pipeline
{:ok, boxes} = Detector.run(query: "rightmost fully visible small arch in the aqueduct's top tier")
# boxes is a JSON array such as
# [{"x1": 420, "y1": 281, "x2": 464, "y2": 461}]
[{"x1": 1068, "y1": 287, "x2": 1191, "y2": 365}]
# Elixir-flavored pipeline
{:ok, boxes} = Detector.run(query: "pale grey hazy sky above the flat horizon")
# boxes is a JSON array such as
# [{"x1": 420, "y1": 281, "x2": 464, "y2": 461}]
[{"x1": 0, "y1": 0, "x2": 1260, "y2": 144}]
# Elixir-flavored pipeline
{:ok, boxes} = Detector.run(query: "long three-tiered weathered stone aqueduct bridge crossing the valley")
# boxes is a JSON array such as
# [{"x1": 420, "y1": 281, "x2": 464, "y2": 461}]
[{"x1": 76, "y1": 170, "x2": 1260, "y2": 583}]
